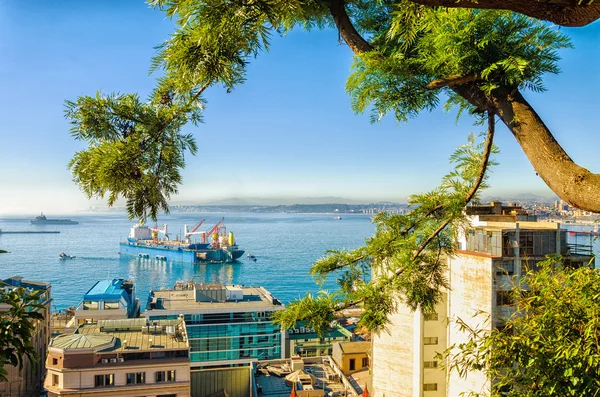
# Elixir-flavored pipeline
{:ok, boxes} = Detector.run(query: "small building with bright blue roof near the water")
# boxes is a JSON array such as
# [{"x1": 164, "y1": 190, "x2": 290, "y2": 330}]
[{"x1": 72, "y1": 279, "x2": 140, "y2": 325}]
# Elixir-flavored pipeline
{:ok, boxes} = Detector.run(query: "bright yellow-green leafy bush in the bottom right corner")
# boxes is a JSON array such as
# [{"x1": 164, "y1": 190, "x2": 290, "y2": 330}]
[{"x1": 445, "y1": 257, "x2": 600, "y2": 397}]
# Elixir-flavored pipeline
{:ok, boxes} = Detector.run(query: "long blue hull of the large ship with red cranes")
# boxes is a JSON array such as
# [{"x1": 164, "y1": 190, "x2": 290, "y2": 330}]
[{"x1": 119, "y1": 242, "x2": 244, "y2": 264}]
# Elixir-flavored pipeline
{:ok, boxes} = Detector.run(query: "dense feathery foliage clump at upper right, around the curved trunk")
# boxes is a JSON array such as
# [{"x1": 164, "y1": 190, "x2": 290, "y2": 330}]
[{"x1": 347, "y1": 4, "x2": 571, "y2": 121}]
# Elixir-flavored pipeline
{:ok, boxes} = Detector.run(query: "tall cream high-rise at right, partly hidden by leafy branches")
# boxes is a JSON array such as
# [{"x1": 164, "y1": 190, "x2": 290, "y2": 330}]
[{"x1": 372, "y1": 203, "x2": 592, "y2": 397}]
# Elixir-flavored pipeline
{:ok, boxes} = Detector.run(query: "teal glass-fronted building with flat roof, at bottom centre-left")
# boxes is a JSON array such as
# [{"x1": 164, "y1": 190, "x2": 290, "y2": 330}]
[{"x1": 144, "y1": 281, "x2": 284, "y2": 397}]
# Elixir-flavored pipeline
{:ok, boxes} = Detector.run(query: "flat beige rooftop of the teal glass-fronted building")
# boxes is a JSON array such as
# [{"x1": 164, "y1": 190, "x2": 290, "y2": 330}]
[{"x1": 146, "y1": 286, "x2": 283, "y2": 315}]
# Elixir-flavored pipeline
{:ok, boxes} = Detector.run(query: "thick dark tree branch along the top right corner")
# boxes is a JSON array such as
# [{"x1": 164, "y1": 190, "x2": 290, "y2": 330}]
[{"x1": 411, "y1": 0, "x2": 600, "y2": 26}]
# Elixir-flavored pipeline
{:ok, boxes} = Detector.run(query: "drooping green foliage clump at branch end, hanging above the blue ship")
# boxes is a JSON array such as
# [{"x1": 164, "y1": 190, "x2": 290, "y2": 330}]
[{"x1": 66, "y1": 93, "x2": 200, "y2": 221}]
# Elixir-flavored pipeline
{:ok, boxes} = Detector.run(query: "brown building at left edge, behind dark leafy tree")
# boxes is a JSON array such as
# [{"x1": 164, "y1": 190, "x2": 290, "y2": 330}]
[{"x1": 0, "y1": 276, "x2": 52, "y2": 397}]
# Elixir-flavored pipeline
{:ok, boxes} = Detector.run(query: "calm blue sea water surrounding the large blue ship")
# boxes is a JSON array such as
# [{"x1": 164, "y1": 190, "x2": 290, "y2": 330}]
[{"x1": 0, "y1": 213, "x2": 375, "y2": 310}]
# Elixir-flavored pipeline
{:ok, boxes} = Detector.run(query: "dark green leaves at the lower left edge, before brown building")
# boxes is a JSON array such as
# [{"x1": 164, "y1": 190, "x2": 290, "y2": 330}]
[{"x1": 0, "y1": 288, "x2": 44, "y2": 381}]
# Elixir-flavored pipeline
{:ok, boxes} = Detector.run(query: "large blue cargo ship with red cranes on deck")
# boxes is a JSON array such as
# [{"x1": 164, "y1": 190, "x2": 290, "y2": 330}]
[{"x1": 119, "y1": 218, "x2": 244, "y2": 264}]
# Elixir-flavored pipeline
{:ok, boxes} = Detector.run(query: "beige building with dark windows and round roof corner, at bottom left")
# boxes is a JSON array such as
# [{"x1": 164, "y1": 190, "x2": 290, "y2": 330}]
[{"x1": 44, "y1": 319, "x2": 190, "y2": 397}]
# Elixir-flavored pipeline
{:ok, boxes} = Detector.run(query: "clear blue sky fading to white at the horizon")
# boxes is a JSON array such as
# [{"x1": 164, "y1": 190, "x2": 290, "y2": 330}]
[{"x1": 0, "y1": 0, "x2": 600, "y2": 214}]
